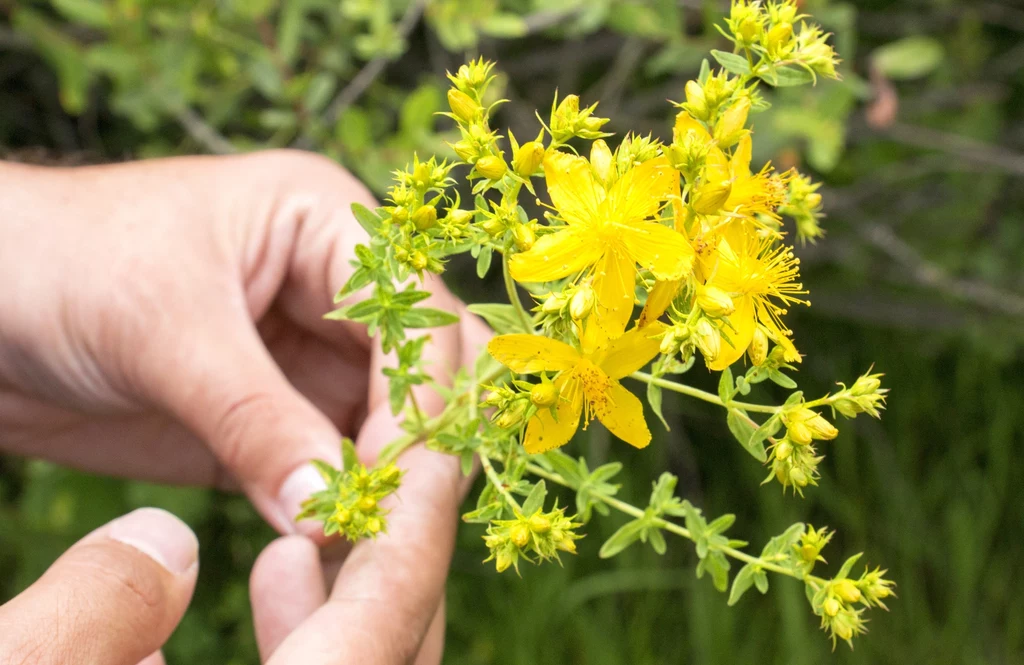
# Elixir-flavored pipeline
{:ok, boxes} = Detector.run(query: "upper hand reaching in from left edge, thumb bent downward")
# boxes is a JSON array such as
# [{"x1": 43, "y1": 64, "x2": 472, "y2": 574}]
[{"x1": 0, "y1": 152, "x2": 486, "y2": 533}]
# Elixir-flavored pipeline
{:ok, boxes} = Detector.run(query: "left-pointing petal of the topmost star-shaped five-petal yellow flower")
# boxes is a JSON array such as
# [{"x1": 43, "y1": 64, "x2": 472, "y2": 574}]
[{"x1": 509, "y1": 226, "x2": 602, "y2": 282}]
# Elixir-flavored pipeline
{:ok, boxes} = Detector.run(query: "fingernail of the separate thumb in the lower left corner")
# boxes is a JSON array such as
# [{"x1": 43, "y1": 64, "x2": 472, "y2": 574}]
[{"x1": 110, "y1": 508, "x2": 199, "y2": 574}]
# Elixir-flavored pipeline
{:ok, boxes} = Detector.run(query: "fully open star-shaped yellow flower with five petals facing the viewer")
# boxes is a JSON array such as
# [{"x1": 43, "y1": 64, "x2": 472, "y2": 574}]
[{"x1": 509, "y1": 151, "x2": 693, "y2": 337}]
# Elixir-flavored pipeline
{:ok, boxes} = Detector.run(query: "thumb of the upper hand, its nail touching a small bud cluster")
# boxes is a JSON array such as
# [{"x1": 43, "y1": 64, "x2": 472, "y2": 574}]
[{"x1": 142, "y1": 311, "x2": 341, "y2": 538}]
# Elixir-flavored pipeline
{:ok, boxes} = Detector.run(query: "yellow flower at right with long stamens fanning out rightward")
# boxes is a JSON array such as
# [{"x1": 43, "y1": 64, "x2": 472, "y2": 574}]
[{"x1": 708, "y1": 238, "x2": 809, "y2": 371}]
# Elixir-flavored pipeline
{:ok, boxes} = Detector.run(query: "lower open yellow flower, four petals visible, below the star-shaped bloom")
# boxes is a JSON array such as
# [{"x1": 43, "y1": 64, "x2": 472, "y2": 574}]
[{"x1": 487, "y1": 324, "x2": 663, "y2": 454}]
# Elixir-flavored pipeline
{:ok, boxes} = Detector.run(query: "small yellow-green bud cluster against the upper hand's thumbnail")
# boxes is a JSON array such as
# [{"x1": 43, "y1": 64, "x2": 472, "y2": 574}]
[{"x1": 296, "y1": 439, "x2": 402, "y2": 542}]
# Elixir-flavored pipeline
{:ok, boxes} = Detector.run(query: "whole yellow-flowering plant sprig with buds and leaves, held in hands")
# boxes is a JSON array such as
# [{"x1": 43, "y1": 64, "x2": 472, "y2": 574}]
[{"x1": 302, "y1": 0, "x2": 893, "y2": 646}]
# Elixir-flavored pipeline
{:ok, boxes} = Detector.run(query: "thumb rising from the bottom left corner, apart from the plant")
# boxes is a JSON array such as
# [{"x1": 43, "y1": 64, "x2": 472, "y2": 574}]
[{"x1": 0, "y1": 508, "x2": 199, "y2": 665}]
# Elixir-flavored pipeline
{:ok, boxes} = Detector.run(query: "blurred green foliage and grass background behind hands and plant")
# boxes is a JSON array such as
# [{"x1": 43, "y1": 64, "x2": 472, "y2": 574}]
[{"x1": 0, "y1": 0, "x2": 1024, "y2": 665}]
